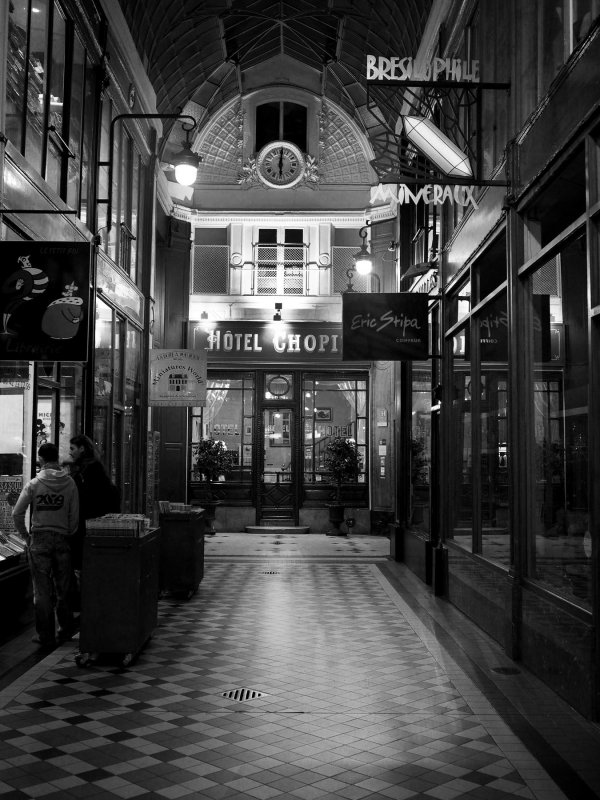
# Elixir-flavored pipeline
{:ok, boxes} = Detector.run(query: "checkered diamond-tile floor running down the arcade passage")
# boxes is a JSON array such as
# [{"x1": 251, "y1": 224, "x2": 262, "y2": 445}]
[{"x1": 0, "y1": 534, "x2": 592, "y2": 800}]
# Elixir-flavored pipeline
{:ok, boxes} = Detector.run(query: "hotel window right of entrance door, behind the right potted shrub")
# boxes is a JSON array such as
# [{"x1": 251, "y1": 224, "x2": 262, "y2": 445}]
[{"x1": 302, "y1": 376, "x2": 368, "y2": 483}]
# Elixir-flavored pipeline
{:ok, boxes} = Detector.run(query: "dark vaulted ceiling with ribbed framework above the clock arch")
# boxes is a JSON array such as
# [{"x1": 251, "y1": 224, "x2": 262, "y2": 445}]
[{"x1": 119, "y1": 0, "x2": 433, "y2": 152}]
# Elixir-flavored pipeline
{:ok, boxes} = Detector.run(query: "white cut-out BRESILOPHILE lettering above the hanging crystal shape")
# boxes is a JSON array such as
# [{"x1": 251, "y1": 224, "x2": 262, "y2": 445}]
[{"x1": 365, "y1": 55, "x2": 479, "y2": 83}]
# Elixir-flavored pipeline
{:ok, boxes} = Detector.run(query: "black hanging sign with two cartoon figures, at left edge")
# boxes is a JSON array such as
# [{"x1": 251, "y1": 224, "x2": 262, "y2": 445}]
[{"x1": 0, "y1": 242, "x2": 92, "y2": 361}]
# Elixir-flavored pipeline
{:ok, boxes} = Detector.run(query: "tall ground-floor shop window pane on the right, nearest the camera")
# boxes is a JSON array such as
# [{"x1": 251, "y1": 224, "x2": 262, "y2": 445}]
[{"x1": 529, "y1": 241, "x2": 592, "y2": 609}]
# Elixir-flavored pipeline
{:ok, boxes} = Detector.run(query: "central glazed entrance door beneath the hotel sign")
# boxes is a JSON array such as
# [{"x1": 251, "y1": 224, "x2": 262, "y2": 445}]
[{"x1": 258, "y1": 406, "x2": 299, "y2": 525}]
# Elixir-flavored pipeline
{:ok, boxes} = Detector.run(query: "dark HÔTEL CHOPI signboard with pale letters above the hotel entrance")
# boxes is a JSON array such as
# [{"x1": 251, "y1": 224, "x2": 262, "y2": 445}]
[{"x1": 188, "y1": 321, "x2": 342, "y2": 364}]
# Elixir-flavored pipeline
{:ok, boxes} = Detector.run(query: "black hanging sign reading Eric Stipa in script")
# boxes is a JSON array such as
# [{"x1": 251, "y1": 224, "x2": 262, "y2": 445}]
[{"x1": 342, "y1": 292, "x2": 429, "y2": 361}]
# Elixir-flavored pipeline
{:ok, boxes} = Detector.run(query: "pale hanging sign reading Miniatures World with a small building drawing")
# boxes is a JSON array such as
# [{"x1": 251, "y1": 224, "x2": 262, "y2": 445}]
[{"x1": 148, "y1": 349, "x2": 206, "y2": 406}]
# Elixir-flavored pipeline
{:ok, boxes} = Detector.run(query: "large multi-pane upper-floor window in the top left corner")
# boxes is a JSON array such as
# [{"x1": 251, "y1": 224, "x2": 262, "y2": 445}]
[{"x1": 6, "y1": 0, "x2": 100, "y2": 222}]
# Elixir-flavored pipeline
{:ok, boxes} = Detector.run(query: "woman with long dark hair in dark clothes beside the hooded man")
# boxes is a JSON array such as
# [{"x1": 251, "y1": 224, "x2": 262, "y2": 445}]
[{"x1": 69, "y1": 434, "x2": 121, "y2": 571}]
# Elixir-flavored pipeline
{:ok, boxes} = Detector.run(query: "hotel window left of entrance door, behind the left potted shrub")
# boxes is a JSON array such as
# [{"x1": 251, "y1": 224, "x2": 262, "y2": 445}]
[{"x1": 189, "y1": 373, "x2": 255, "y2": 483}]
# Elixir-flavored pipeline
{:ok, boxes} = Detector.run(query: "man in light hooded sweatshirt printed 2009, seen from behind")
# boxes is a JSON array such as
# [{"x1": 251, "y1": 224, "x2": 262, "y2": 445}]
[{"x1": 13, "y1": 443, "x2": 79, "y2": 648}]
